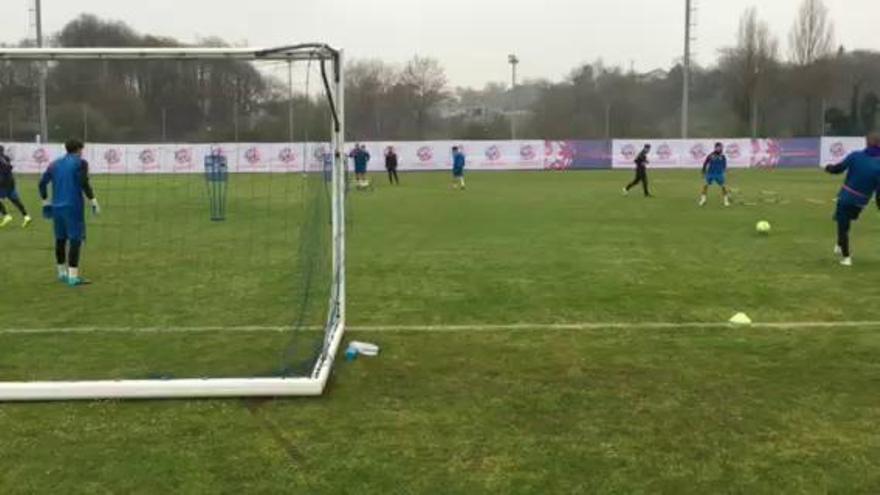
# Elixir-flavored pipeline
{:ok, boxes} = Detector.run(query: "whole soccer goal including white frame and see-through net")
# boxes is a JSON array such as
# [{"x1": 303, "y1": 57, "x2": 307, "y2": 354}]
[{"x1": 0, "y1": 44, "x2": 345, "y2": 401}]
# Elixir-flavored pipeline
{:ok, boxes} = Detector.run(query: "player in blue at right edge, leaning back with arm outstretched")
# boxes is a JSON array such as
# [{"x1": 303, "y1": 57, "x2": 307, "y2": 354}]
[{"x1": 825, "y1": 133, "x2": 880, "y2": 266}]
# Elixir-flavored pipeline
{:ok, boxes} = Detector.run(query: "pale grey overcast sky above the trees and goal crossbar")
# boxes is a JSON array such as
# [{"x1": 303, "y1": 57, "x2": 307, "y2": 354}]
[{"x1": 0, "y1": 0, "x2": 880, "y2": 86}]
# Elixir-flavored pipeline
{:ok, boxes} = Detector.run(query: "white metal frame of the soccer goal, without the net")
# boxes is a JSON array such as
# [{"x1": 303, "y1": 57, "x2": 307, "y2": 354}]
[{"x1": 0, "y1": 43, "x2": 346, "y2": 402}]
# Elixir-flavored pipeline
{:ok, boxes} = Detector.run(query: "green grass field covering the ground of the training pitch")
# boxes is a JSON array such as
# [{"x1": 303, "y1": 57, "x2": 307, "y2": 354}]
[{"x1": 0, "y1": 170, "x2": 880, "y2": 494}]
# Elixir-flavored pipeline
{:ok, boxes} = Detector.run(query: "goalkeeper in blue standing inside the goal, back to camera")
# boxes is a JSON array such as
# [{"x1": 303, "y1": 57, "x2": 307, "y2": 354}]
[{"x1": 40, "y1": 140, "x2": 101, "y2": 287}]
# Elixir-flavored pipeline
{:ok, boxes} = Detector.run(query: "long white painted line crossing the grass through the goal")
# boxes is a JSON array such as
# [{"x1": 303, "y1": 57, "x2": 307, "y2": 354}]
[{"x1": 0, "y1": 321, "x2": 880, "y2": 335}]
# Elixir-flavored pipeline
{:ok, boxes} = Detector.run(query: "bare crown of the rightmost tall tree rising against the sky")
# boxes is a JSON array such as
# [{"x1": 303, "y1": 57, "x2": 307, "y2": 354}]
[{"x1": 788, "y1": 0, "x2": 834, "y2": 66}]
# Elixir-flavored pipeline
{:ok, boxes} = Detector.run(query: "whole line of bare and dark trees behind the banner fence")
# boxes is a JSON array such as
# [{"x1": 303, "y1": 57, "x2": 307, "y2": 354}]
[{"x1": 0, "y1": 0, "x2": 880, "y2": 142}]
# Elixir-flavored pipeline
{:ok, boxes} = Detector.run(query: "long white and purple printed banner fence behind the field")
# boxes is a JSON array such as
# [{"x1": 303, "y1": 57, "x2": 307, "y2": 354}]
[{"x1": 0, "y1": 137, "x2": 865, "y2": 174}]
